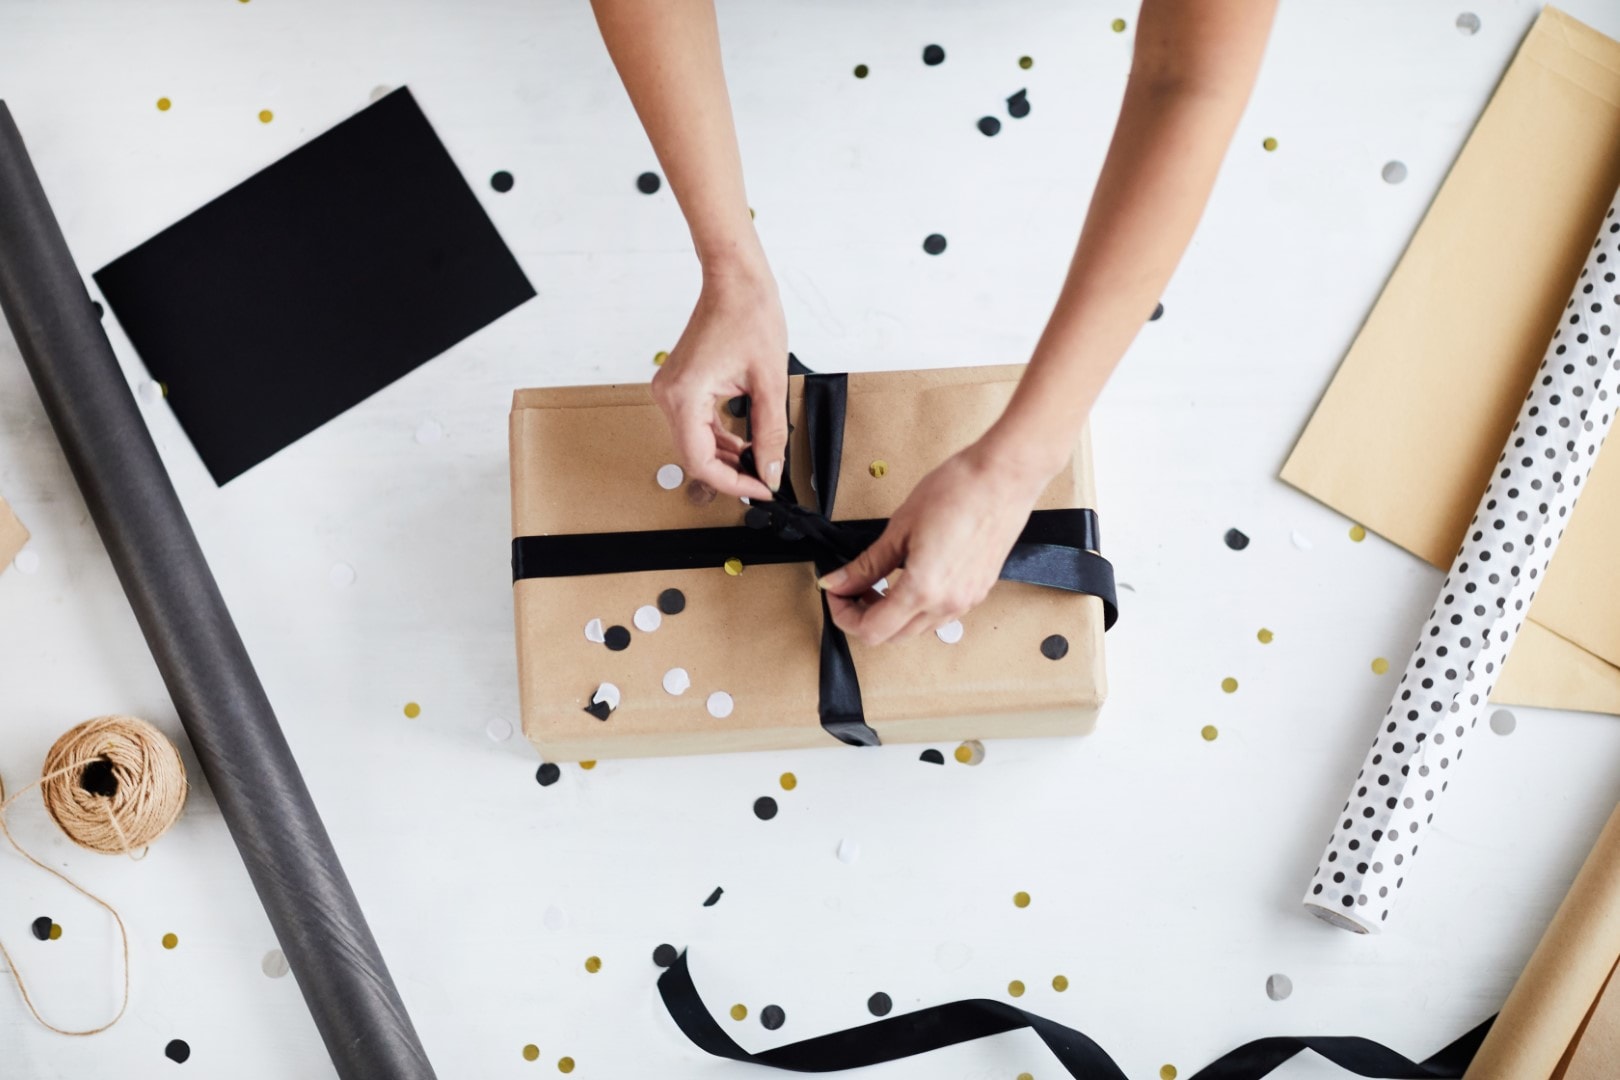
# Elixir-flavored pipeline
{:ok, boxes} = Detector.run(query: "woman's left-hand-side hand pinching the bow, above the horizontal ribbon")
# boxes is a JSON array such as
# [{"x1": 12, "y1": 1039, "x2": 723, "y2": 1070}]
[{"x1": 653, "y1": 256, "x2": 787, "y2": 499}]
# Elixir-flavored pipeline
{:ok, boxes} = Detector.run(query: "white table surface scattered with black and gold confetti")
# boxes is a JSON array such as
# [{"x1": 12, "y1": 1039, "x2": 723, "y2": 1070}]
[{"x1": 0, "y1": 0, "x2": 1620, "y2": 1080}]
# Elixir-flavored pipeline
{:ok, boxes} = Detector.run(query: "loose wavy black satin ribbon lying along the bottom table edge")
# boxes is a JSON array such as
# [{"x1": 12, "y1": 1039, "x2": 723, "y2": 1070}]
[{"x1": 658, "y1": 952, "x2": 1495, "y2": 1080}]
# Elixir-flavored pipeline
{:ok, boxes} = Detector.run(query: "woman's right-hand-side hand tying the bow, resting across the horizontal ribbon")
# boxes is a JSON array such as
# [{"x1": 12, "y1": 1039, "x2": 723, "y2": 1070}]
[{"x1": 821, "y1": 440, "x2": 1056, "y2": 644}]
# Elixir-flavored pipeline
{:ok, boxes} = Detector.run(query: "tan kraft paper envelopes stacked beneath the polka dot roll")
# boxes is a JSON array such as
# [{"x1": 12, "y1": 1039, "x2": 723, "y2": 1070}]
[{"x1": 1281, "y1": 6, "x2": 1620, "y2": 712}]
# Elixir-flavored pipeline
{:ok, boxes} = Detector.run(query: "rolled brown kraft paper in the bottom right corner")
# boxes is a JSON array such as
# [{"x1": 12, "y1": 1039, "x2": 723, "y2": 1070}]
[{"x1": 1466, "y1": 810, "x2": 1620, "y2": 1080}]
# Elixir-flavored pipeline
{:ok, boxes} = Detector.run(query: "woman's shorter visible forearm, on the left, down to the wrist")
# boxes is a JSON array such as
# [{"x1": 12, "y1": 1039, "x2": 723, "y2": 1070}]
[{"x1": 591, "y1": 0, "x2": 765, "y2": 274}]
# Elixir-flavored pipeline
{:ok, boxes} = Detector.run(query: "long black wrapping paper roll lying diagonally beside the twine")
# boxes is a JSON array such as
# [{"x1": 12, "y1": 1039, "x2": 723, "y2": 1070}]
[{"x1": 0, "y1": 102, "x2": 434, "y2": 1080}]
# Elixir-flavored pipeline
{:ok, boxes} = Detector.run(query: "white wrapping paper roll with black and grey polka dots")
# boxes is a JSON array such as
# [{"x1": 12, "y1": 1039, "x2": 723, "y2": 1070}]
[{"x1": 1304, "y1": 183, "x2": 1620, "y2": 933}]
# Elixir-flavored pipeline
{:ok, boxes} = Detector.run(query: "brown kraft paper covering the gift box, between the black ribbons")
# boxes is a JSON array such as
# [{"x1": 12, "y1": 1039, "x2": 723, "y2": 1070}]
[{"x1": 512, "y1": 366, "x2": 1106, "y2": 761}]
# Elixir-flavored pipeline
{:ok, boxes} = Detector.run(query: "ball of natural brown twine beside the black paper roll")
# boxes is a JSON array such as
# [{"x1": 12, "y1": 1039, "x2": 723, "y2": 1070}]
[{"x1": 39, "y1": 716, "x2": 186, "y2": 855}]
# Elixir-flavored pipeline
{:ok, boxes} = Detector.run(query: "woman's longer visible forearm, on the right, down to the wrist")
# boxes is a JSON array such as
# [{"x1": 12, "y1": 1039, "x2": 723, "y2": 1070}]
[{"x1": 982, "y1": 0, "x2": 1275, "y2": 479}]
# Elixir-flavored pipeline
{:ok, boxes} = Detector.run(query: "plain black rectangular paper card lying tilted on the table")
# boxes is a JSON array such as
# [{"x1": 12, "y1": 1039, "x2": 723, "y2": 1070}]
[{"x1": 96, "y1": 89, "x2": 535, "y2": 484}]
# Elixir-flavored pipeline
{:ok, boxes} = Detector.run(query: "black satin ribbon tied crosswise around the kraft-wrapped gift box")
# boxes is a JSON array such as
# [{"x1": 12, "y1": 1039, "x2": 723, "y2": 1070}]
[{"x1": 512, "y1": 356, "x2": 1119, "y2": 746}]
